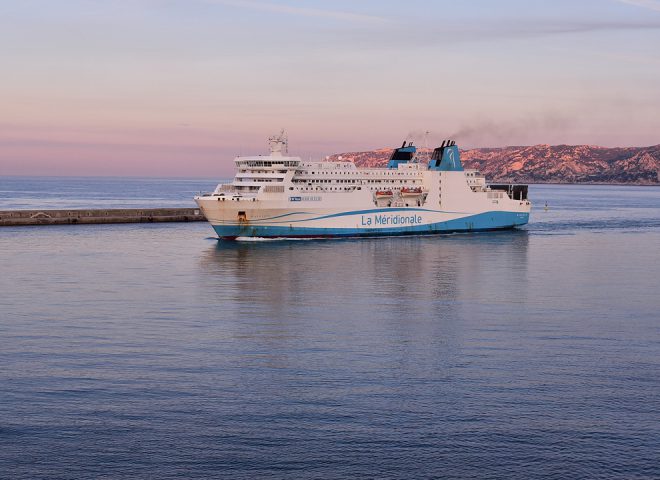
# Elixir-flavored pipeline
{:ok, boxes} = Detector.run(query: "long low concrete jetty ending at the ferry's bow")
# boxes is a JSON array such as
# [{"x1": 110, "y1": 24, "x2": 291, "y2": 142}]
[{"x1": 0, "y1": 208, "x2": 206, "y2": 226}]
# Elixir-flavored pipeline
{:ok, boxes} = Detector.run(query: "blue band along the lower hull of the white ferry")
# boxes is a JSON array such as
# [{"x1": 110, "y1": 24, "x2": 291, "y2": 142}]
[{"x1": 213, "y1": 212, "x2": 529, "y2": 238}]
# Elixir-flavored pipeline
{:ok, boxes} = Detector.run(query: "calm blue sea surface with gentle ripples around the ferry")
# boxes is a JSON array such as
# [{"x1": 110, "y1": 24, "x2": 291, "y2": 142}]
[{"x1": 0, "y1": 178, "x2": 660, "y2": 479}]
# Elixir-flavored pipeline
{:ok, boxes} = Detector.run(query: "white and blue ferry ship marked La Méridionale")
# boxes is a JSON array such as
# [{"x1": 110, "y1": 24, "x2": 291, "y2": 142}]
[{"x1": 195, "y1": 132, "x2": 531, "y2": 239}]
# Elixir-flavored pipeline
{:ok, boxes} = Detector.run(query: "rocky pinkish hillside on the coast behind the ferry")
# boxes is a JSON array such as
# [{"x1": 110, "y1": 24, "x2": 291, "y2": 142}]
[{"x1": 330, "y1": 145, "x2": 660, "y2": 185}]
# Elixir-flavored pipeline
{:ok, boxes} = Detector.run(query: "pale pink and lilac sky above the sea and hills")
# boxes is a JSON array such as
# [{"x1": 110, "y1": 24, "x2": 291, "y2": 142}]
[{"x1": 0, "y1": 0, "x2": 660, "y2": 177}]
